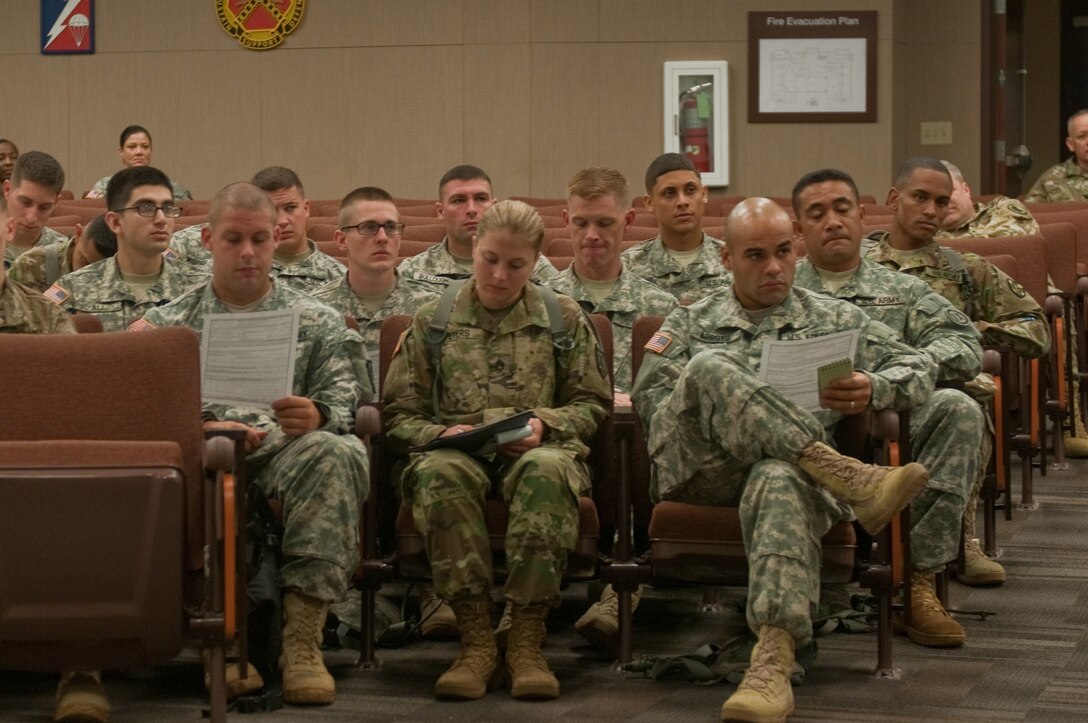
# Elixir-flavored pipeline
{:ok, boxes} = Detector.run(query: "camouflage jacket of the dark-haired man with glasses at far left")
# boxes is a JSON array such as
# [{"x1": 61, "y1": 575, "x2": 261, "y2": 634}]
[{"x1": 45, "y1": 257, "x2": 208, "y2": 332}]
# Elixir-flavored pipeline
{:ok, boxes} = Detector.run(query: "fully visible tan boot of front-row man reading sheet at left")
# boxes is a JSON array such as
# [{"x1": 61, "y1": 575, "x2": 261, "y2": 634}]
[{"x1": 280, "y1": 590, "x2": 336, "y2": 706}]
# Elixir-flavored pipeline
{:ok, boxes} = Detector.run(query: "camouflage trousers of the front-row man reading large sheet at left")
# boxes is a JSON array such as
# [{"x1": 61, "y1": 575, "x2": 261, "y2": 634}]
[{"x1": 246, "y1": 428, "x2": 370, "y2": 601}]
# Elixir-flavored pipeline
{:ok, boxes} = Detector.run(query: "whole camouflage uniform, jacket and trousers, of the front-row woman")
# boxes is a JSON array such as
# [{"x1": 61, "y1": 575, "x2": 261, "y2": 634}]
[{"x1": 383, "y1": 281, "x2": 611, "y2": 606}]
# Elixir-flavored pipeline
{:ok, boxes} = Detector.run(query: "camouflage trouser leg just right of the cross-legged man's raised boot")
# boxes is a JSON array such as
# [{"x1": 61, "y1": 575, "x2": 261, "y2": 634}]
[{"x1": 910, "y1": 389, "x2": 989, "y2": 571}]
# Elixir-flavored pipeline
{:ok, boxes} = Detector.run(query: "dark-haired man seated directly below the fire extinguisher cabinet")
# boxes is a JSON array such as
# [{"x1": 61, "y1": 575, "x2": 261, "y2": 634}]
[{"x1": 623, "y1": 153, "x2": 729, "y2": 303}]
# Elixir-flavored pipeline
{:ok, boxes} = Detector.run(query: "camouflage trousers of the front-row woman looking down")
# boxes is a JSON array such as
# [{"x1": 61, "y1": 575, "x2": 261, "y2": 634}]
[{"x1": 404, "y1": 447, "x2": 590, "y2": 606}]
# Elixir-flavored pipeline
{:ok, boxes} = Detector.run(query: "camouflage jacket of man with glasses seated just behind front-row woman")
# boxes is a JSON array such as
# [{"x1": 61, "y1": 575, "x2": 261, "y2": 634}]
[{"x1": 311, "y1": 269, "x2": 444, "y2": 389}]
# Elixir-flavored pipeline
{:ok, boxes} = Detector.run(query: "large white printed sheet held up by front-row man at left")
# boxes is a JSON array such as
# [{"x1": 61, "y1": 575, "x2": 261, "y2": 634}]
[{"x1": 200, "y1": 309, "x2": 299, "y2": 408}]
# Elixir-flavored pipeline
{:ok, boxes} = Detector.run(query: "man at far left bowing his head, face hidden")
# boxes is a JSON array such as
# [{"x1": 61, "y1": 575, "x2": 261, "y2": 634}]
[{"x1": 11, "y1": 214, "x2": 118, "y2": 292}]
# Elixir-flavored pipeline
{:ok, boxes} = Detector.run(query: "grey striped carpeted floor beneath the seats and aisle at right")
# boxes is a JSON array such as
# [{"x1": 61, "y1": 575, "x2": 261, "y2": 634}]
[{"x1": 0, "y1": 454, "x2": 1088, "y2": 723}]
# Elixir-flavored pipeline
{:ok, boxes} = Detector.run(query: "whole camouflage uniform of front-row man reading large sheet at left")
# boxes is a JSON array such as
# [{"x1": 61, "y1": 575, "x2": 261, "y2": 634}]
[{"x1": 138, "y1": 282, "x2": 370, "y2": 601}]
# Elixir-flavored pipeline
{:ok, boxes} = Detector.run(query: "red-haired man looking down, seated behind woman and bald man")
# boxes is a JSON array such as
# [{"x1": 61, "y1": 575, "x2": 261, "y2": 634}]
[{"x1": 548, "y1": 167, "x2": 677, "y2": 652}]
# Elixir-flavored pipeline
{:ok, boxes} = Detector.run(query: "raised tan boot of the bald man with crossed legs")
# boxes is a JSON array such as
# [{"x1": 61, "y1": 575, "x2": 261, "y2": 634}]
[{"x1": 798, "y1": 441, "x2": 929, "y2": 535}]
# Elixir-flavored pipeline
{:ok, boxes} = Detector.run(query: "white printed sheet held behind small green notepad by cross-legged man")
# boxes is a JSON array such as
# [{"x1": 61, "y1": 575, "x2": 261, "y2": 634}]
[{"x1": 759, "y1": 328, "x2": 861, "y2": 412}]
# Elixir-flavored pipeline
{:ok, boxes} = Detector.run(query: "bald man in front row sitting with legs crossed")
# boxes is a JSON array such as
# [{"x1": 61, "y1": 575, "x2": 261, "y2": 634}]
[{"x1": 631, "y1": 198, "x2": 936, "y2": 721}]
